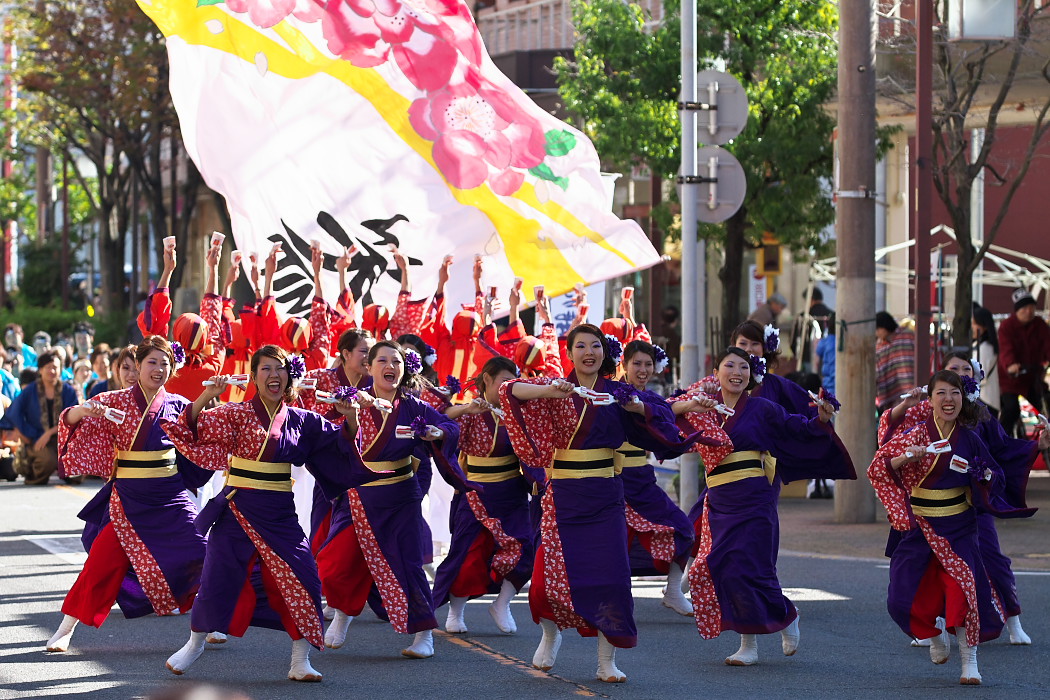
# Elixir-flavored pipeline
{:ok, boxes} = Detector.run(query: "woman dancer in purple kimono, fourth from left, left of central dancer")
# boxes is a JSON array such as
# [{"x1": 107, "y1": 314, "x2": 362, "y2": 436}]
[{"x1": 434, "y1": 357, "x2": 533, "y2": 634}]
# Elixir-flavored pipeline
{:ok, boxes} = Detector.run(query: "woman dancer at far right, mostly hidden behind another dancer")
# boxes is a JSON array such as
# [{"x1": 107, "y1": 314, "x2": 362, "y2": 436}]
[{"x1": 879, "y1": 352, "x2": 1050, "y2": 645}]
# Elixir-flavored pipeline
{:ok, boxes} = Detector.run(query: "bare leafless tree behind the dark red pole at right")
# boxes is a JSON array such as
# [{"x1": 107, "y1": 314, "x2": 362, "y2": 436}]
[{"x1": 882, "y1": 0, "x2": 1050, "y2": 345}]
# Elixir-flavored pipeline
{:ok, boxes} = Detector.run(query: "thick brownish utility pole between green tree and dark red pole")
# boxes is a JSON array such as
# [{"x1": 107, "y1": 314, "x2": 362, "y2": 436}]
[{"x1": 835, "y1": 0, "x2": 876, "y2": 523}]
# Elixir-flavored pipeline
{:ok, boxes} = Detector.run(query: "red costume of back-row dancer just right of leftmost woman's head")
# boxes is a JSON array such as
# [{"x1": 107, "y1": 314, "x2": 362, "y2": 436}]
[{"x1": 165, "y1": 294, "x2": 226, "y2": 401}]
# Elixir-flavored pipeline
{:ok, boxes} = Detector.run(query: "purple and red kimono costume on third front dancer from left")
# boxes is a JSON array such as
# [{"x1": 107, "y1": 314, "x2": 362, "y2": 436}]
[{"x1": 317, "y1": 393, "x2": 468, "y2": 634}]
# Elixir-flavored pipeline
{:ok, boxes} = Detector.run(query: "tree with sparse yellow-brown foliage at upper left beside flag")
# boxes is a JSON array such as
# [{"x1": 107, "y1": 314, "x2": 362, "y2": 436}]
[{"x1": 12, "y1": 0, "x2": 211, "y2": 309}]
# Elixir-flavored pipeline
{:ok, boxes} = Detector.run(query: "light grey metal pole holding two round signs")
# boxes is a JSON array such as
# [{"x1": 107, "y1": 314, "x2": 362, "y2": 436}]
[{"x1": 678, "y1": 0, "x2": 705, "y2": 507}]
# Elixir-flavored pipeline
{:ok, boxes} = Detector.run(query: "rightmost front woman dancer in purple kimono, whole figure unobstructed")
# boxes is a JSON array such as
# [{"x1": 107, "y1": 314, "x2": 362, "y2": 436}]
[{"x1": 867, "y1": 369, "x2": 1024, "y2": 685}]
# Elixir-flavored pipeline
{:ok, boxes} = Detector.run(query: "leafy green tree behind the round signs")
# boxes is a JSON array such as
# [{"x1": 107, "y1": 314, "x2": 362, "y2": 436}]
[{"x1": 555, "y1": 0, "x2": 837, "y2": 326}]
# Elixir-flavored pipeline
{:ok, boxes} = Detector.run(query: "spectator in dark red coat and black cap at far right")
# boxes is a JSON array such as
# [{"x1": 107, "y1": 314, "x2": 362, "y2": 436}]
[{"x1": 999, "y1": 289, "x2": 1050, "y2": 437}]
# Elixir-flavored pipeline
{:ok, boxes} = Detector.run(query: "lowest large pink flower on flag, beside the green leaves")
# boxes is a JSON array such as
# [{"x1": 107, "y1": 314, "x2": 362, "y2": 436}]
[{"x1": 408, "y1": 79, "x2": 546, "y2": 195}]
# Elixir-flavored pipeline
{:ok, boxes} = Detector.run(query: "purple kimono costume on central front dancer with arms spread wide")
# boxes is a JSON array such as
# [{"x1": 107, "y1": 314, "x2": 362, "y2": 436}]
[{"x1": 500, "y1": 372, "x2": 698, "y2": 648}]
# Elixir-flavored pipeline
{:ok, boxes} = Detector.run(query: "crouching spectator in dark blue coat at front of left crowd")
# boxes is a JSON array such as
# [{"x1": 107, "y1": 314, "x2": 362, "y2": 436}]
[{"x1": 11, "y1": 351, "x2": 83, "y2": 486}]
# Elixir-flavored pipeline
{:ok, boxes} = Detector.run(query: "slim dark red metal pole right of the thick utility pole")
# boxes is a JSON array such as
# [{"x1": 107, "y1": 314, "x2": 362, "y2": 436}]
[{"x1": 911, "y1": 0, "x2": 933, "y2": 384}]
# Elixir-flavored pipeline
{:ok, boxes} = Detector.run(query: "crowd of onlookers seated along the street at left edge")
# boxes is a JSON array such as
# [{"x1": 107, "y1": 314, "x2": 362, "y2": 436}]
[{"x1": 0, "y1": 323, "x2": 137, "y2": 485}]
